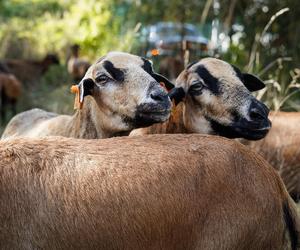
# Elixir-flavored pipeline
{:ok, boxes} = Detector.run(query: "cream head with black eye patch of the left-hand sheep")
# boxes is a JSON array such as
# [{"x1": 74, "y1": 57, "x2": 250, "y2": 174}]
[{"x1": 79, "y1": 52, "x2": 171, "y2": 131}]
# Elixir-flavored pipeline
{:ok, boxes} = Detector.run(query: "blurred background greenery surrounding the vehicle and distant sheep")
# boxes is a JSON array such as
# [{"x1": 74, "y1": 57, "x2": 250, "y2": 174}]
[{"x1": 0, "y1": 0, "x2": 300, "y2": 133}]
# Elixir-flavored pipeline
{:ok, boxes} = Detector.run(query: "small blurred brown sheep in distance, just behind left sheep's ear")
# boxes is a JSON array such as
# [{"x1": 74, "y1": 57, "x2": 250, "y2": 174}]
[{"x1": 67, "y1": 44, "x2": 91, "y2": 82}]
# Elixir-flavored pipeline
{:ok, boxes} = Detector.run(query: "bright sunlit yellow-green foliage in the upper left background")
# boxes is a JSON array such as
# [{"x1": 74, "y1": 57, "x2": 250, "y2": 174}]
[{"x1": 0, "y1": 0, "x2": 138, "y2": 60}]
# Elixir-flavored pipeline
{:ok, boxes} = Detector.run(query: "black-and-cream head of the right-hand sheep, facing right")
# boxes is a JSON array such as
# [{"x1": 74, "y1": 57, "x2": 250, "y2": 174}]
[{"x1": 176, "y1": 58, "x2": 271, "y2": 140}]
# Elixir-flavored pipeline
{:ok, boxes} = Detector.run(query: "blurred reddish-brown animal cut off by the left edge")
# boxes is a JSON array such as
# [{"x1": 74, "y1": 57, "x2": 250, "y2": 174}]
[{"x1": 0, "y1": 73, "x2": 22, "y2": 123}]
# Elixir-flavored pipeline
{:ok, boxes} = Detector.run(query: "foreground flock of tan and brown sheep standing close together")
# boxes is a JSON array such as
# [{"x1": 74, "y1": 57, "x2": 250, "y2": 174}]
[{"x1": 0, "y1": 52, "x2": 300, "y2": 250}]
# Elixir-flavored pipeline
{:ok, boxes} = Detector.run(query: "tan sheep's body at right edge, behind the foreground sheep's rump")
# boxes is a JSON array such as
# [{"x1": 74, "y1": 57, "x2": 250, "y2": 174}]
[{"x1": 243, "y1": 112, "x2": 300, "y2": 201}]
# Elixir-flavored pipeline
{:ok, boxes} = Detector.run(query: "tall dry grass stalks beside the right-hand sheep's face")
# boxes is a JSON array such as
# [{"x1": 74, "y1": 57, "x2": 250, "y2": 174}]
[{"x1": 247, "y1": 8, "x2": 300, "y2": 111}]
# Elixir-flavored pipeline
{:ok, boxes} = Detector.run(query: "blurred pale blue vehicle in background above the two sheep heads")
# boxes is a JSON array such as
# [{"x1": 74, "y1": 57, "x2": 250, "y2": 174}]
[{"x1": 139, "y1": 22, "x2": 208, "y2": 79}]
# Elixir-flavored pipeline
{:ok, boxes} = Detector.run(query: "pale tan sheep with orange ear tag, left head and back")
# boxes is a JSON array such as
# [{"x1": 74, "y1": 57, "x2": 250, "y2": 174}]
[{"x1": 2, "y1": 52, "x2": 172, "y2": 139}]
